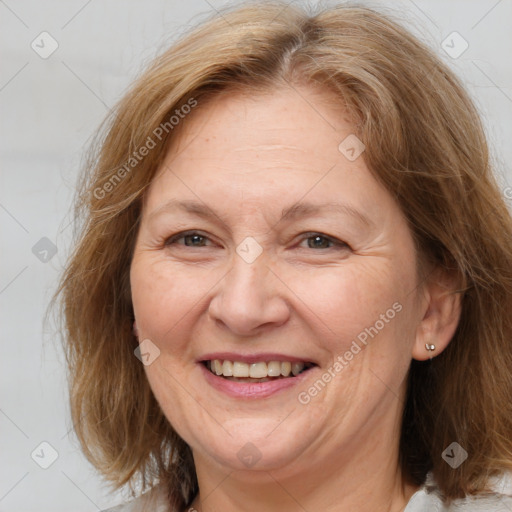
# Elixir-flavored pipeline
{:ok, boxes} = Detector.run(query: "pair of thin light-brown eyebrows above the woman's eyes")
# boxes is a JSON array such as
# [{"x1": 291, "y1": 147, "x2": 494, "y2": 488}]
[{"x1": 149, "y1": 199, "x2": 375, "y2": 227}]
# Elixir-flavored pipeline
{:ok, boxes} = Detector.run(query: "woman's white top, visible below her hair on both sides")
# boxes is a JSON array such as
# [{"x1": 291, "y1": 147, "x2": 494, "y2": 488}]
[{"x1": 103, "y1": 473, "x2": 512, "y2": 512}]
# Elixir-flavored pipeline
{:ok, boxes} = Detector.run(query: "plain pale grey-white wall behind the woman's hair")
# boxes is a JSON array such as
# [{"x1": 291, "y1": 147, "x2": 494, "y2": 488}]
[{"x1": 0, "y1": 0, "x2": 512, "y2": 512}]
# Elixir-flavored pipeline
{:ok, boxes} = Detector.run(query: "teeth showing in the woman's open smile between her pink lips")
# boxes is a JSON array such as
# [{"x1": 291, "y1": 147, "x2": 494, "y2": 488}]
[{"x1": 203, "y1": 359, "x2": 316, "y2": 382}]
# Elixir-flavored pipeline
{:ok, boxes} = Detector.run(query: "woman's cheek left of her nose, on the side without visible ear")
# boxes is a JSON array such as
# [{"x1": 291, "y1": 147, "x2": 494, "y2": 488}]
[{"x1": 130, "y1": 251, "x2": 207, "y2": 420}]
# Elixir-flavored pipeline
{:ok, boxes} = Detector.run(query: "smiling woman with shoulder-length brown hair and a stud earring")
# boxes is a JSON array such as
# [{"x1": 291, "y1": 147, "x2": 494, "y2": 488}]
[{"x1": 61, "y1": 3, "x2": 512, "y2": 512}]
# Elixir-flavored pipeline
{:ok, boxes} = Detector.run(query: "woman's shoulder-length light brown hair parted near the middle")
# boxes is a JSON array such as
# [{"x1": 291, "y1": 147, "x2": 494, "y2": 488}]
[{"x1": 58, "y1": 2, "x2": 512, "y2": 508}]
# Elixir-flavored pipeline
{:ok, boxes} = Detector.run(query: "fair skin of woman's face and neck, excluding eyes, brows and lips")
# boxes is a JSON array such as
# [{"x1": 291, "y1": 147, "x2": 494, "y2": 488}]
[{"x1": 131, "y1": 87, "x2": 456, "y2": 511}]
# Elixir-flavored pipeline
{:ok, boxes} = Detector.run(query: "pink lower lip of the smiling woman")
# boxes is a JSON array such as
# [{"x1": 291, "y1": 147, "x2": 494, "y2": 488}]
[{"x1": 199, "y1": 363, "x2": 314, "y2": 398}]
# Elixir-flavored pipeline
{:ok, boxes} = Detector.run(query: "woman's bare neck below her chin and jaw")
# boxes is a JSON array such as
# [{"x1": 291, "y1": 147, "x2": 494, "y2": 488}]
[{"x1": 185, "y1": 418, "x2": 418, "y2": 512}]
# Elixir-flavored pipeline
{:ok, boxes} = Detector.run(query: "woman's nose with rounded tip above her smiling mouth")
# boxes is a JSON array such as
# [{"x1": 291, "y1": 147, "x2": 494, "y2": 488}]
[{"x1": 209, "y1": 254, "x2": 290, "y2": 336}]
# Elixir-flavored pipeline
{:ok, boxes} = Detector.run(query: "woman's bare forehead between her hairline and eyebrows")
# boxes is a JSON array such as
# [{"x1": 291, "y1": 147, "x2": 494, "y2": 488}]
[{"x1": 142, "y1": 86, "x2": 389, "y2": 222}]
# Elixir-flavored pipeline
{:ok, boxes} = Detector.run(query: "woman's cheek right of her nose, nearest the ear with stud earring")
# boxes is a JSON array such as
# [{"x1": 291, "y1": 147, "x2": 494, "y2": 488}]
[{"x1": 306, "y1": 257, "x2": 415, "y2": 388}]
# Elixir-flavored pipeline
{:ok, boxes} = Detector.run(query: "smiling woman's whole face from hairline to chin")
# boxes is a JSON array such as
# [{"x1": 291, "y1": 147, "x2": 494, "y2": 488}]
[{"x1": 131, "y1": 87, "x2": 424, "y2": 480}]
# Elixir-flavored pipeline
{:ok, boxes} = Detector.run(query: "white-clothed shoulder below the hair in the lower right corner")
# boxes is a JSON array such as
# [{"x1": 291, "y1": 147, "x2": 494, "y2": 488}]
[{"x1": 404, "y1": 473, "x2": 512, "y2": 512}]
